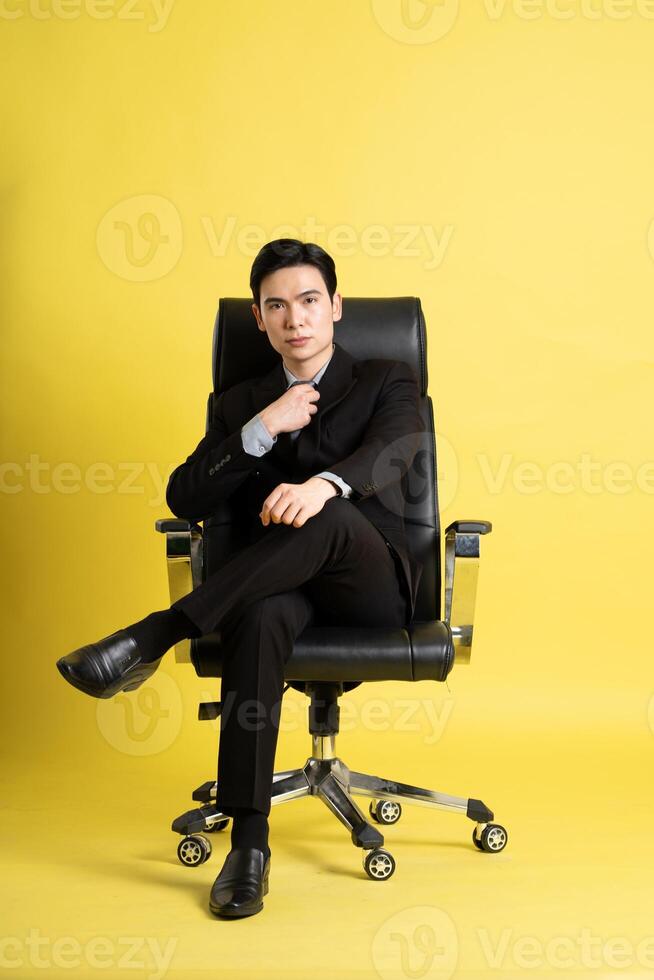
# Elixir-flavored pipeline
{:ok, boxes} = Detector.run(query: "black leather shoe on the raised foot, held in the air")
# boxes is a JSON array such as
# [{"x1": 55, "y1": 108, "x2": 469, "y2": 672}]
[{"x1": 57, "y1": 630, "x2": 163, "y2": 698}]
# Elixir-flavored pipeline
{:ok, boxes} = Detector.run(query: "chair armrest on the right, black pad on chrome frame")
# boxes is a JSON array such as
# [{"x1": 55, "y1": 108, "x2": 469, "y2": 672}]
[{"x1": 443, "y1": 521, "x2": 493, "y2": 664}]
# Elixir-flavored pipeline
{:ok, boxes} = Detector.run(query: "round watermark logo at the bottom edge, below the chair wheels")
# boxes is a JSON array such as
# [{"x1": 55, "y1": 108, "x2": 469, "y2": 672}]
[{"x1": 371, "y1": 905, "x2": 459, "y2": 980}]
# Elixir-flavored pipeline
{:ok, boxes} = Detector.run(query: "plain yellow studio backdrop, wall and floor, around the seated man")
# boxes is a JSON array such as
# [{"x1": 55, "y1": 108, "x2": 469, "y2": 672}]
[{"x1": 0, "y1": 0, "x2": 654, "y2": 978}]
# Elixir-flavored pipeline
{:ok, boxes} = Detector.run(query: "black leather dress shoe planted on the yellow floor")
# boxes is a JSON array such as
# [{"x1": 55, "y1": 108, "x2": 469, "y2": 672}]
[{"x1": 209, "y1": 847, "x2": 270, "y2": 919}]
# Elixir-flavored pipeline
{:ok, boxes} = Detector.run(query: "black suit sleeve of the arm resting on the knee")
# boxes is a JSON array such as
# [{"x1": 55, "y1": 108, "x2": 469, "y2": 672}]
[{"x1": 329, "y1": 361, "x2": 424, "y2": 500}]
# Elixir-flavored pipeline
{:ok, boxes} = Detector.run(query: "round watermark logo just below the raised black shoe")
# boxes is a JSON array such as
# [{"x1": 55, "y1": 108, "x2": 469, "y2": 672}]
[{"x1": 96, "y1": 671, "x2": 184, "y2": 755}]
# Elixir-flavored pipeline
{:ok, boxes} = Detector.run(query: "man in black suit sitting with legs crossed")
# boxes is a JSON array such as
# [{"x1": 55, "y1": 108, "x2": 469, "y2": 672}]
[{"x1": 57, "y1": 239, "x2": 423, "y2": 918}]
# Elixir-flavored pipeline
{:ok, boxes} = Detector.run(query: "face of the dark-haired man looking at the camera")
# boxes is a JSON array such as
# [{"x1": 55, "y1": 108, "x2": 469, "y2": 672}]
[{"x1": 252, "y1": 265, "x2": 342, "y2": 378}]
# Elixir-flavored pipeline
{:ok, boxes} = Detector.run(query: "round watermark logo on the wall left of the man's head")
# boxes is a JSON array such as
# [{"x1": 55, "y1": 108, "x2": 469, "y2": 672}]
[{"x1": 96, "y1": 194, "x2": 183, "y2": 282}]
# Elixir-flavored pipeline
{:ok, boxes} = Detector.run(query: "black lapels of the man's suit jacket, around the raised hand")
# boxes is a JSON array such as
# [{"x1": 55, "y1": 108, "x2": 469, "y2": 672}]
[{"x1": 251, "y1": 341, "x2": 356, "y2": 471}]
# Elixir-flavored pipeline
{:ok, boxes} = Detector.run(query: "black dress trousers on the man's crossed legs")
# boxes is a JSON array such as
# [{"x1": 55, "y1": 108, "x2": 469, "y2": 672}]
[{"x1": 172, "y1": 497, "x2": 408, "y2": 814}]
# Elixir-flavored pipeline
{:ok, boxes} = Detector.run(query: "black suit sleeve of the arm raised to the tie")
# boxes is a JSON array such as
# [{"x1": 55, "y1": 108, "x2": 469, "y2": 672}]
[{"x1": 166, "y1": 392, "x2": 258, "y2": 521}]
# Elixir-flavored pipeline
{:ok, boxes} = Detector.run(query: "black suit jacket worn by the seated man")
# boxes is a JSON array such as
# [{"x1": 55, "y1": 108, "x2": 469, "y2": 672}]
[{"x1": 166, "y1": 342, "x2": 423, "y2": 618}]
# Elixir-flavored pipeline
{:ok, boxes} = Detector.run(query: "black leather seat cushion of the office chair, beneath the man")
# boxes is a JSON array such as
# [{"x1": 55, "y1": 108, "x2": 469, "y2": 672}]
[{"x1": 191, "y1": 621, "x2": 454, "y2": 681}]
